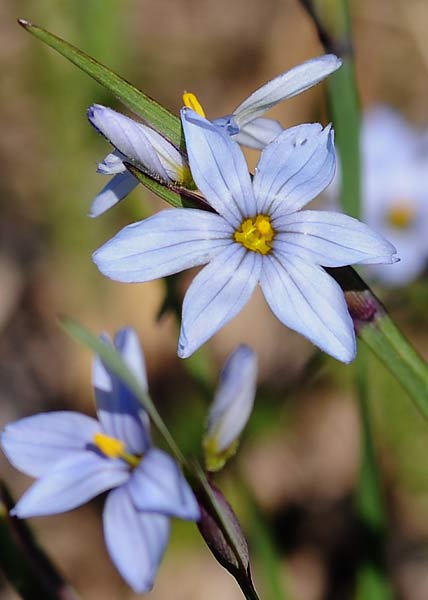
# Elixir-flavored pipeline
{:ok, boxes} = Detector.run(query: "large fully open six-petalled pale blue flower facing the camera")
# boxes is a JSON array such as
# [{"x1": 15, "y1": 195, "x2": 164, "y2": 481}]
[{"x1": 94, "y1": 109, "x2": 395, "y2": 362}]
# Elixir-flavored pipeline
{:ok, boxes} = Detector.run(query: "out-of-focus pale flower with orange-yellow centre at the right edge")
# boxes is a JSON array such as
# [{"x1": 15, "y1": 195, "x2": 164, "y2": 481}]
[{"x1": 361, "y1": 106, "x2": 428, "y2": 286}]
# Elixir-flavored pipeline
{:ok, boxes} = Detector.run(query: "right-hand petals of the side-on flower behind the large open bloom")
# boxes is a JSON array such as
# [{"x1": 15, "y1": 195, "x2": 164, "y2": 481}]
[{"x1": 213, "y1": 54, "x2": 342, "y2": 150}]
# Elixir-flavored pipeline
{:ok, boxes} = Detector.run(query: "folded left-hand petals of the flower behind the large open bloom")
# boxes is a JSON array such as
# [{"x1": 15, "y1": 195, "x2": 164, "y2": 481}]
[{"x1": 88, "y1": 104, "x2": 192, "y2": 217}]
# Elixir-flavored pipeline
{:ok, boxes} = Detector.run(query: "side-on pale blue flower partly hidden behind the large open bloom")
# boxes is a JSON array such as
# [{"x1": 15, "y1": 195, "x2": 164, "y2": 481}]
[{"x1": 88, "y1": 54, "x2": 342, "y2": 217}]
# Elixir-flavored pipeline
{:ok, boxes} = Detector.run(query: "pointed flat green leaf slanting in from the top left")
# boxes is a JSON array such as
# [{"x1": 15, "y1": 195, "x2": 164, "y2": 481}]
[{"x1": 18, "y1": 19, "x2": 183, "y2": 147}]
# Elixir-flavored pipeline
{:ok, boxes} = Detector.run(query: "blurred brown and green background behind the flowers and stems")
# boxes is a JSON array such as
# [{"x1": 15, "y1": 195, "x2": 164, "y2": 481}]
[{"x1": 0, "y1": 0, "x2": 428, "y2": 600}]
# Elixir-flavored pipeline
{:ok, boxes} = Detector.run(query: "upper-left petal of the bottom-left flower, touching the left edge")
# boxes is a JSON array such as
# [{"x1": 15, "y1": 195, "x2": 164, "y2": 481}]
[{"x1": 1, "y1": 411, "x2": 100, "y2": 477}]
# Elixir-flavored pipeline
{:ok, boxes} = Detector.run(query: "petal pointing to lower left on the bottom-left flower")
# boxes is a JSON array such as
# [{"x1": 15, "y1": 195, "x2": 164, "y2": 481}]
[{"x1": 12, "y1": 450, "x2": 129, "y2": 519}]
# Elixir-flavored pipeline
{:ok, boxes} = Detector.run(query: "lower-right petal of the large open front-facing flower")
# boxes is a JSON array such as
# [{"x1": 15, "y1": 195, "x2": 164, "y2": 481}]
[{"x1": 260, "y1": 252, "x2": 356, "y2": 363}]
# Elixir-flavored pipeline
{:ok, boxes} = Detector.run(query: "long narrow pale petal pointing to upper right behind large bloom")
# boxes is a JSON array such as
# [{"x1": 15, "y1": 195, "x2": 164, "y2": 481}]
[{"x1": 233, "y1": 54, "x2": 342, "y2": 127}]
